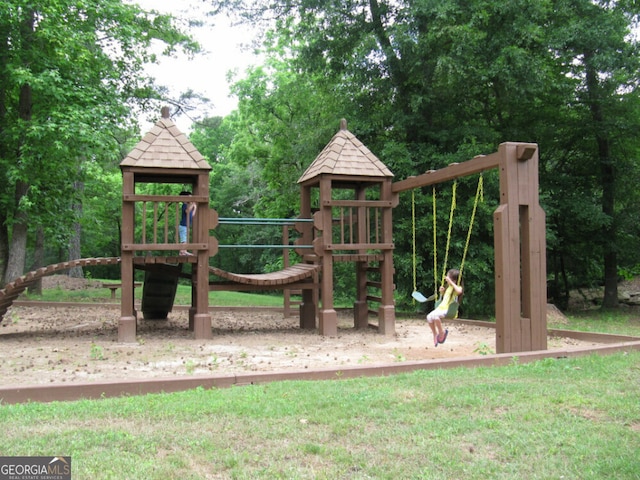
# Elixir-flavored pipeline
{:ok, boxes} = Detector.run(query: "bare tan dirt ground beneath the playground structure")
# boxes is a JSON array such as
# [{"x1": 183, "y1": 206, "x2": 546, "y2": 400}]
[{"x1": 0, "y1": 276, "x2": 604, "y2": 386}]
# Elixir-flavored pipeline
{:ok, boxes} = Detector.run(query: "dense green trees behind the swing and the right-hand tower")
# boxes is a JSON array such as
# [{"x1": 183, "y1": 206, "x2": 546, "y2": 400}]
[{"x1": 202, "y1": 0, "x2": 640, "y2": 313}]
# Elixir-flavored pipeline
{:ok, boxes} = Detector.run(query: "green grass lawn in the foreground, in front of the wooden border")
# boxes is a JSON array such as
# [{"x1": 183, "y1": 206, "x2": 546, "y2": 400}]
[{"x1": 0, "y1": 351, "x2": 640, "y2": 480}]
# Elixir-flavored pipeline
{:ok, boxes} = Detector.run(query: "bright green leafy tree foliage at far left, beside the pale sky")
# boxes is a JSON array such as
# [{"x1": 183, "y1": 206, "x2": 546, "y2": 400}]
[{"x1": 0, "y1": 0, "x2": 198, "y2": 275}]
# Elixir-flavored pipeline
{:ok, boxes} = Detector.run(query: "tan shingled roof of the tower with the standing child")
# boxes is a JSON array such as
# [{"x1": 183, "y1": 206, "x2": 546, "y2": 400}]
[{"x1": 120, "y1": 117, "x2": 211, "y2": 170}]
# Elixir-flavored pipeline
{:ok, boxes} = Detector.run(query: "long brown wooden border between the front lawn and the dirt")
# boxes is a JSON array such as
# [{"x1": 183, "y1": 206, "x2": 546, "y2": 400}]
[{"x1": 0, "y1": 340, "x2": 640, "y2": 405}]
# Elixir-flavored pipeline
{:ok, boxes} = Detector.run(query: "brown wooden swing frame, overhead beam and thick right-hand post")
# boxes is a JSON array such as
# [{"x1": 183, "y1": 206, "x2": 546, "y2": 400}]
[{"x1": 392, "y1": 142, "x2": 547, "y2": 353}]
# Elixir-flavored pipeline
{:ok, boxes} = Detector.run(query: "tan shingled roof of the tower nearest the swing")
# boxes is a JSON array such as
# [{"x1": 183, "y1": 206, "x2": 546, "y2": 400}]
[{"x1": 298, "y1": 124, "x2": 393, "y2": 183}]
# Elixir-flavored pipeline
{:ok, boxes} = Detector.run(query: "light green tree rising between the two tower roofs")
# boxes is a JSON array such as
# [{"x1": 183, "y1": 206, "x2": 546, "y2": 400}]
[{"x1": 230, "y1": 57, "x2": 339, "y2": 217}]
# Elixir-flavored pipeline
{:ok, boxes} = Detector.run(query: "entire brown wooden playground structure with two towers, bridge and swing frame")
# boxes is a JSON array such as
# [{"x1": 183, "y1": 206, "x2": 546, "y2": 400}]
[{"x1": 0, "y1": 108, "x2": 547, "y2": 353}]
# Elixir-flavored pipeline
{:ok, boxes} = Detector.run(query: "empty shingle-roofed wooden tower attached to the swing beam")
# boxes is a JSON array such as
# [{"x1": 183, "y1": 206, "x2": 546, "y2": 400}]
[{"x1": 298, "y1": 119, "x2": 397, "y2": 335}]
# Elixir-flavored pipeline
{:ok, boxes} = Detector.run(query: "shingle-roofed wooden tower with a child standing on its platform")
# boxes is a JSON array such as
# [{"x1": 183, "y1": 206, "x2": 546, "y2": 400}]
[{"x1": 118, "y1": 107, "x2": 212, "y2": 342}]
